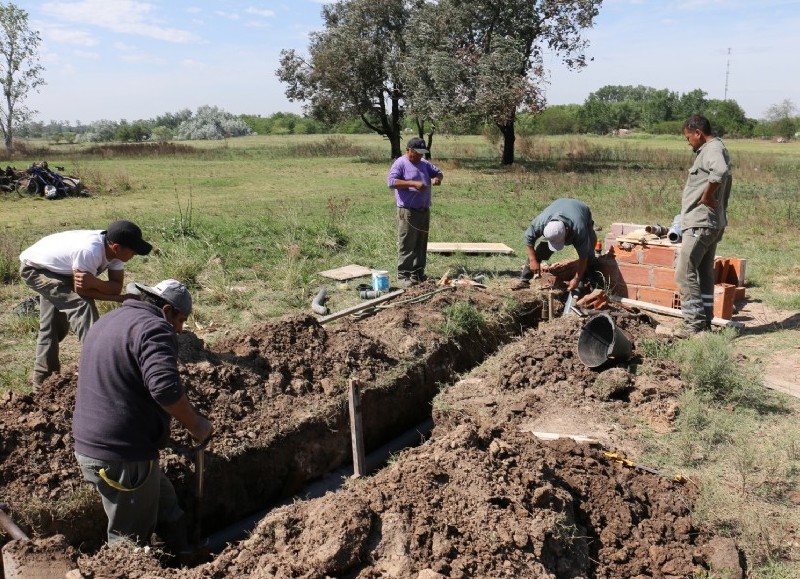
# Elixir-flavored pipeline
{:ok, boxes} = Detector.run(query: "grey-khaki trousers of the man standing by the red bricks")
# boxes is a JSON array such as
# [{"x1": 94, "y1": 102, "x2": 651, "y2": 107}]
[{"x1": 675, "y1": 227, "x2": 722, "y2": 332}]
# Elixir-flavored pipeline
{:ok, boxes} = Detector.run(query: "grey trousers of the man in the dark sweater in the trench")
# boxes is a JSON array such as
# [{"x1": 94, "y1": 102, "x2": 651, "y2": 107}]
[{"x1": 75, "y1": 452, "x2": 183, "y2": 545}]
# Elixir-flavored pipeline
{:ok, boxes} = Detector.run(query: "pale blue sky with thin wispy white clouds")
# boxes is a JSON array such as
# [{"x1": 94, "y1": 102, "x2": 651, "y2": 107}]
[{"x1": 10, "y1": 0, "x2": 800, "y2": 125}]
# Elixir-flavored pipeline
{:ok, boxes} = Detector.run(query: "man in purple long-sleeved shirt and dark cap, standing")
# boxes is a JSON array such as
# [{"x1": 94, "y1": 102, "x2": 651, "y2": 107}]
[{"x1": 387, "y1": 137, "x2": 444, "y2": 287}]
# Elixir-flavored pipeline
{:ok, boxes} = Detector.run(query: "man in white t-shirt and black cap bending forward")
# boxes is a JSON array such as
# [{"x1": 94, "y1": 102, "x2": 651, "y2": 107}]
[{"x1": 19, "y1": 220, "x2": 153, "y2": 390}]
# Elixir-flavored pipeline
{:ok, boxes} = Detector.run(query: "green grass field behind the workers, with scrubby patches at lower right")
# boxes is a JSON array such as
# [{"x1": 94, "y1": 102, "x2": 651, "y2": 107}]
[{"x1": 0, "y1": 135, "x2": 800, "y2": 578}]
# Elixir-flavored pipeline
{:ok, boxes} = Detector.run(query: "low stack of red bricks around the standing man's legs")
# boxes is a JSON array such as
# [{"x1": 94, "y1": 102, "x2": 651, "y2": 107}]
[{"x1": 600, "y1": 223, "x2": 747, "y2": 320}]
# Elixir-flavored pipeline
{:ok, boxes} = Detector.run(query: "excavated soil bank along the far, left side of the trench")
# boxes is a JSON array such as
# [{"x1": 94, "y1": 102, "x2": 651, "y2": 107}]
[{"x1": 0, "y1": 282, "x2": 540, "y2": 549}]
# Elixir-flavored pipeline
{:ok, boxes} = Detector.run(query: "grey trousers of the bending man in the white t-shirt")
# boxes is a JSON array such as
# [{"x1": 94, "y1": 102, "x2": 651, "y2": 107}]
[{"x1": 19, "y1": 265, "x2": 100, "y2": 384}]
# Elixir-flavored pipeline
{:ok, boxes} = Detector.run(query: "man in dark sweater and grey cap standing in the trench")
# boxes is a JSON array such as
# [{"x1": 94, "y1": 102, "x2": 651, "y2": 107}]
[{"x1": 72, "y1": 279, "x2": 213, "y2": 555}]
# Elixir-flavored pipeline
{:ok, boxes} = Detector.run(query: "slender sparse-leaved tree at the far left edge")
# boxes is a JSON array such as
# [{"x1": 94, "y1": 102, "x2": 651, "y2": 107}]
[{"x1": 0, "y1": 3, "x2": 44, "y2": 151}]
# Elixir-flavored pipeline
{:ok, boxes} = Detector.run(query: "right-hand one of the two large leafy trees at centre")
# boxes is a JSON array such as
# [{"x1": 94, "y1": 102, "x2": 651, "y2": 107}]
[{"x1": 402, "y1": 0, "x2": 602, "y2": 165}]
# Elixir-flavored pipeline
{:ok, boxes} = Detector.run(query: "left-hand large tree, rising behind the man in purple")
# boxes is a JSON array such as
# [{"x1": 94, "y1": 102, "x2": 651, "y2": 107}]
[{"x1": 276, "y1": 0, "x2": 424, "y2": 157}]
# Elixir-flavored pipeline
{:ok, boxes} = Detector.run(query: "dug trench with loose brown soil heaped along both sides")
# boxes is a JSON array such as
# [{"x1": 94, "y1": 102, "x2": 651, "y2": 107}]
[{"x1": 0, "y1": 282, "x2": 739, "y2": 578}]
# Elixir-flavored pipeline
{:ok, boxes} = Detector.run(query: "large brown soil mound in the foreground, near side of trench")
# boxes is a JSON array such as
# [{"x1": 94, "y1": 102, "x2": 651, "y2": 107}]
[{"x1": 78, "y1": 425, "x2": 703, "y2": 578}]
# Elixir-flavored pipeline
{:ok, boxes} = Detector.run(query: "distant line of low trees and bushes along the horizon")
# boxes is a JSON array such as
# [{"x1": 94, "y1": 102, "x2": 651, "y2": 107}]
[{"x1": 18, "y1": 86, "x2": 800, "y2": 144}]
